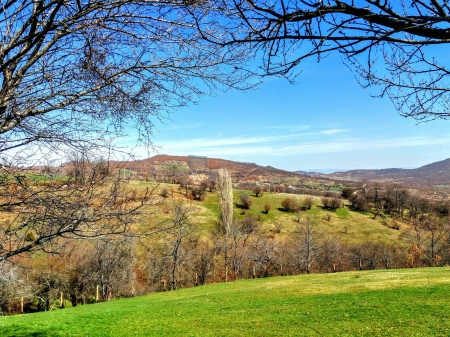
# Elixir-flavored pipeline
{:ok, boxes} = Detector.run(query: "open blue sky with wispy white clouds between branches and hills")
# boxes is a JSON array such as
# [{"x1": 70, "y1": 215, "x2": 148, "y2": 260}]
[{"x1": 120, "y1": 56, "x2": 450, "y2": 170}]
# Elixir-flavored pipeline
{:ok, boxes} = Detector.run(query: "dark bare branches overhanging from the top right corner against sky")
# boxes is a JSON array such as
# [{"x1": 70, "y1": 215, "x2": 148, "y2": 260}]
[{"x1": 192, "y1": 0, "x2": 450, "y2": 120}]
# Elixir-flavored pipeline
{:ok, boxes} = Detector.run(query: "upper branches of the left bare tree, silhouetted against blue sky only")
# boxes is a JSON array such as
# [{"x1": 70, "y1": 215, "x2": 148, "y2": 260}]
[{"x1": 0, "y1": 0, "x2": 253, "y2": 153}]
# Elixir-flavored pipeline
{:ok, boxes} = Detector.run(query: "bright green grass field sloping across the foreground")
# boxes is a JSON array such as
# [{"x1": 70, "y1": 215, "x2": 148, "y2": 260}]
[{"x1": 0, "y1": 267, "x2": 450, "y2": 337}]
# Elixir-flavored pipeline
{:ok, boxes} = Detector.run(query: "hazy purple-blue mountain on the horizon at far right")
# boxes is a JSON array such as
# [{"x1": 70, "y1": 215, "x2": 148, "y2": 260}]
[{"x1": 327, "y1": 158, "x2": 450, "y2": 187}]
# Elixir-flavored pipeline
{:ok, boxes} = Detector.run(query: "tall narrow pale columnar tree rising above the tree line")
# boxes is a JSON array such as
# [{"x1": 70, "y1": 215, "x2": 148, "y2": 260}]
[{"x1": 216, "y1": 169, "x2": 233, "y2": 235}]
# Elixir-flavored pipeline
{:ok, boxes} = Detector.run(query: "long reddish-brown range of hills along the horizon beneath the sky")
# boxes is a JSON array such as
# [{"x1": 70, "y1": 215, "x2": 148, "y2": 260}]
[{"x1": 32, "y1": 154, "x2": 450, "y2": 193}]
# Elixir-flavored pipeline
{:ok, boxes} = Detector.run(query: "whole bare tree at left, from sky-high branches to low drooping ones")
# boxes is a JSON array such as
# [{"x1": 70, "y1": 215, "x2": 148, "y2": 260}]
[{"x1": 0, "y1": 0, "x2": 254, "y2": 261}]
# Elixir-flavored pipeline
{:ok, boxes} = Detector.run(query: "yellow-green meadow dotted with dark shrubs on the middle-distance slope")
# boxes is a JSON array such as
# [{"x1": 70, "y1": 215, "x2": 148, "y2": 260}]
[{"x1": 133, "y1": 182, "x2": 409, "y2": 244}]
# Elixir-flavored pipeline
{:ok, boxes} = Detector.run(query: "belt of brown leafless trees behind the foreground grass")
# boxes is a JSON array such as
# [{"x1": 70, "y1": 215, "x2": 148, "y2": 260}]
[{"x1": 0, "y1": 171, "x2": 450, "y2": 313}]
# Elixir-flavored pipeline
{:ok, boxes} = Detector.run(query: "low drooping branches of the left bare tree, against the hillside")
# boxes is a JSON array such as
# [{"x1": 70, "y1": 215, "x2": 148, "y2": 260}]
[{"x1": 0, "y1": 156, "x2": 162, "y2": 261}]
